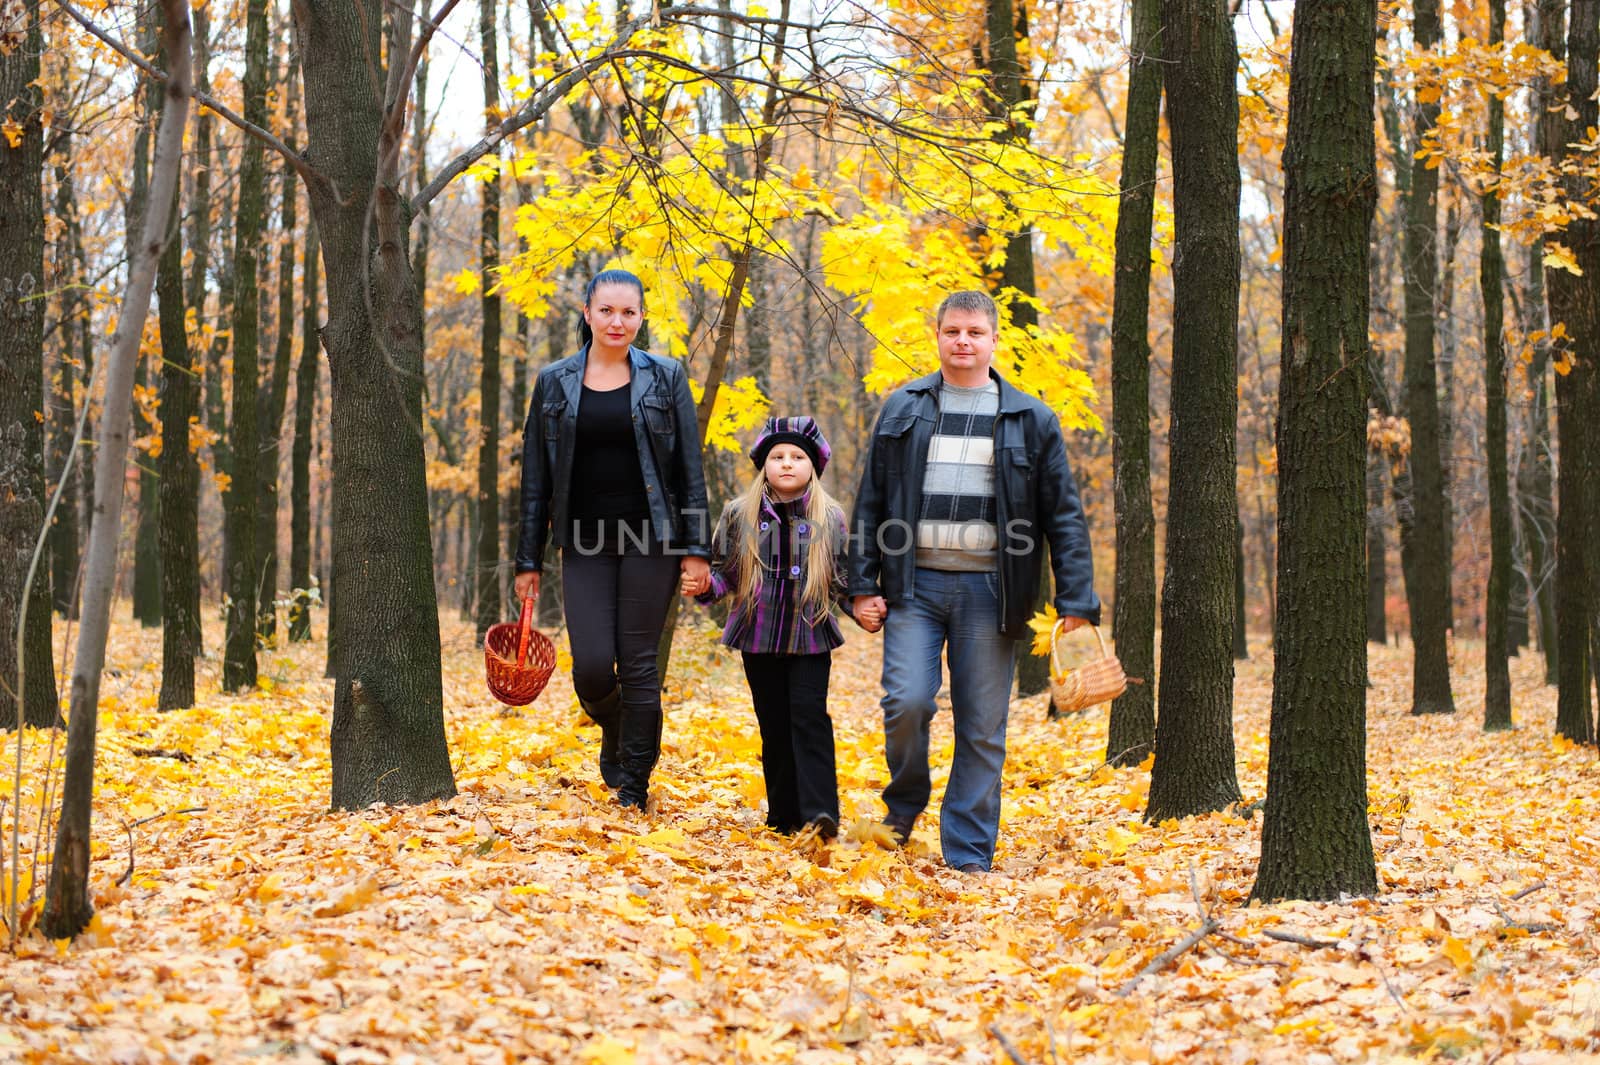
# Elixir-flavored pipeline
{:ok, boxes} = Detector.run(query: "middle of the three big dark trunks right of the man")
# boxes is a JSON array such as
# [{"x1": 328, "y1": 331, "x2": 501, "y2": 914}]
[{"x1": 1144, "y1": 0, "x2": 1241, "y2": 822}]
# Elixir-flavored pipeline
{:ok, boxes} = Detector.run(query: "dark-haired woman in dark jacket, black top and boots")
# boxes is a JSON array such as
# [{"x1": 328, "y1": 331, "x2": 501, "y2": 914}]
[{"x1": 517, "y1": 270, "x2": 710, "y2": 809}]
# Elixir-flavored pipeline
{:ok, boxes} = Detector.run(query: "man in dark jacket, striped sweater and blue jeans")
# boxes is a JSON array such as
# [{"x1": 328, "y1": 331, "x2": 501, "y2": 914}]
[{"x1": 850, "y1": 291, "x2": 1101, "y2": 873}]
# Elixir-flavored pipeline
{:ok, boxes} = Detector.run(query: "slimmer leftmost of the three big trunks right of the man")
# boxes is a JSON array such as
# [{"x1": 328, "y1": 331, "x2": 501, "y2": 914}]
[{"x1": 1106, "y1": 0, "x2": 1162, "y2": 766}]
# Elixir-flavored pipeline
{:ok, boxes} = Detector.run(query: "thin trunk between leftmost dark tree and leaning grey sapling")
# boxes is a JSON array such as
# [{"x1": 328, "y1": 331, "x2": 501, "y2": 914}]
[{"x1": 46, "y1": 147, "x2": 90, "y2": 620}]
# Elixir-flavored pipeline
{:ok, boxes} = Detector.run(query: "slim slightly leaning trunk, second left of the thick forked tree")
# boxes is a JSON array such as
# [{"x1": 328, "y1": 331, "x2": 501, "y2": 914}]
[{"x1": 256, "y1": 62, "x2": 299, "y2": 641}]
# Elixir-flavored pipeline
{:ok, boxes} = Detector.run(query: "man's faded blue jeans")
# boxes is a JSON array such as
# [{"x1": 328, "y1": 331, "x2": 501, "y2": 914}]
[{"x1": 883, "y1": 568, "x2": 1016, "y2": 868}]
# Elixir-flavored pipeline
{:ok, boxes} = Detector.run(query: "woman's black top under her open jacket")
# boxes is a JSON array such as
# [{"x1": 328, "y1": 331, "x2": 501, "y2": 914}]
[{"x1": 571, "y1": 385, "x2": 650, "y2": 553}]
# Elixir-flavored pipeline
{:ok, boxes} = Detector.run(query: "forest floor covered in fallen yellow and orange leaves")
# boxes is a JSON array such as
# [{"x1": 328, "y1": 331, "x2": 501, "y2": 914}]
[{"x1": 0, "y1": 604, "x2": 1600, "y2": 1065}]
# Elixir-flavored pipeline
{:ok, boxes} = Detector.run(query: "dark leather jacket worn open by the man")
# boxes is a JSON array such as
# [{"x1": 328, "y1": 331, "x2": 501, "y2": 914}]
[{"x1": 850, "y1": 369, "x2": 1101, "y2": 638}]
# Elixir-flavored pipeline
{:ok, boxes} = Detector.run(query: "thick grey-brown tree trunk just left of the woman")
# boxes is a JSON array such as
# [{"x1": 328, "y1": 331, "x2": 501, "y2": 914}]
[{"x1": 294, "y1": 0, "x2": 456, "y2": 809}]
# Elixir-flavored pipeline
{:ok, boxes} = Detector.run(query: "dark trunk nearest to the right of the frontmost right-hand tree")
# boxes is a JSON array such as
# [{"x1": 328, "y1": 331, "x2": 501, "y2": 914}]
[{"x1": 1400, "y1": 0, "x2": 1456, "y2": 713}]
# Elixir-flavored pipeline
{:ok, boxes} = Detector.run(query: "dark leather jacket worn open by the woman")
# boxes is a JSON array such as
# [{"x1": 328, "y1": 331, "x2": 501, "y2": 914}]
[{"x1": 517, "y1": 347, "x2": 710, "y2": 572}]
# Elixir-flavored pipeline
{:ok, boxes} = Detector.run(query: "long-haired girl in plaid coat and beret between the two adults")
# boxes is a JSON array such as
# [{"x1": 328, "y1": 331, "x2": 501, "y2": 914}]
[{"x1": 682, "y1": 417, "x2": 846, "y2": 840}]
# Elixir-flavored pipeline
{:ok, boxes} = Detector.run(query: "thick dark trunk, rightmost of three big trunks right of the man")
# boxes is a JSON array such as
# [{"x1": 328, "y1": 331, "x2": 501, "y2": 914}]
[{"x1": 1248, "y1": 0, "x2": 1378, "y2": 900}]
